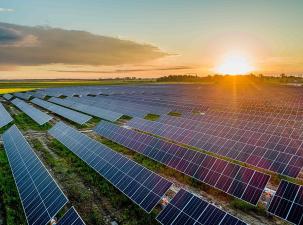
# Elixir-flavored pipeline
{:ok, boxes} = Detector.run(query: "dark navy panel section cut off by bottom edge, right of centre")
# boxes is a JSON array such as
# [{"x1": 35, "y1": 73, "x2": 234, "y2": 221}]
[{"x1": 156, "y1": 189, "x2": 246, "y2": 225}]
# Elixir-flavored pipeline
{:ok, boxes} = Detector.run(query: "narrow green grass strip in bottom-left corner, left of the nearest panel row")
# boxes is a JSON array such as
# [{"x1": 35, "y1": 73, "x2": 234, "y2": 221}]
[{"x1": 0, "y1": 146, "x2": 26, "y2": 225}]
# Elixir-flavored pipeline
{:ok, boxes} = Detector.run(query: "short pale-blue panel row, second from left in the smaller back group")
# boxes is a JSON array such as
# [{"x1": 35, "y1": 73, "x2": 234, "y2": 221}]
[{"x1": 11, "y1": 98, "x2": 53, "y2": 125}]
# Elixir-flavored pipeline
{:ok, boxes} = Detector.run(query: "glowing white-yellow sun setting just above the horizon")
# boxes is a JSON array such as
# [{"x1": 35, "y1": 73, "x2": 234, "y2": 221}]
[{"x1": 215, "y1": 53, "x2": 254, "y2": 75}]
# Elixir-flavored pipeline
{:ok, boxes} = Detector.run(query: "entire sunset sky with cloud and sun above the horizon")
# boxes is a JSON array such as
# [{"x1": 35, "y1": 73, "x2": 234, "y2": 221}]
[{"x1": 0, "y1": 0, "x2": 303, "y2": 79}]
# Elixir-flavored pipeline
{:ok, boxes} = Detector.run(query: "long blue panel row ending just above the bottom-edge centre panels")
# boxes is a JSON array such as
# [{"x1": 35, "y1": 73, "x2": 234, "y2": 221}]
[{"x1": 49, "y1": 122, "x2": 172, "y2": 212}]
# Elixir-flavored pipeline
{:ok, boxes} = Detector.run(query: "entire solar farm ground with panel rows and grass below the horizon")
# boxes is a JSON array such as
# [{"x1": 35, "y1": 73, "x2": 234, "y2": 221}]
[{"x1": 0, "y1": 80, "x2": 303, "y2": 225}]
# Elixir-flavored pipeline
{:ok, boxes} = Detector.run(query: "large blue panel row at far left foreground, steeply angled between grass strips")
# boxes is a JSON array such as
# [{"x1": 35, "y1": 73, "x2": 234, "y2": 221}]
[{"x1": 3, "y1": 125, "x2": 68, "y2": 225}]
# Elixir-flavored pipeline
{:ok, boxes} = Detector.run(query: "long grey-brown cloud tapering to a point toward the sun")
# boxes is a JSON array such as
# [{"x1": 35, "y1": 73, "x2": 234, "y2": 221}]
[{"x1": 0, "y1": 23, "x2": 169, "y2": 66}]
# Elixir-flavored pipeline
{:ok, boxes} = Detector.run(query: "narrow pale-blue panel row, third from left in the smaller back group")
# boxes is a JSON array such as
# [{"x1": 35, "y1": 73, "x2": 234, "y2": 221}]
[{"x1": 31, "y1": 98, "x2": 92, "y2": 125}]
